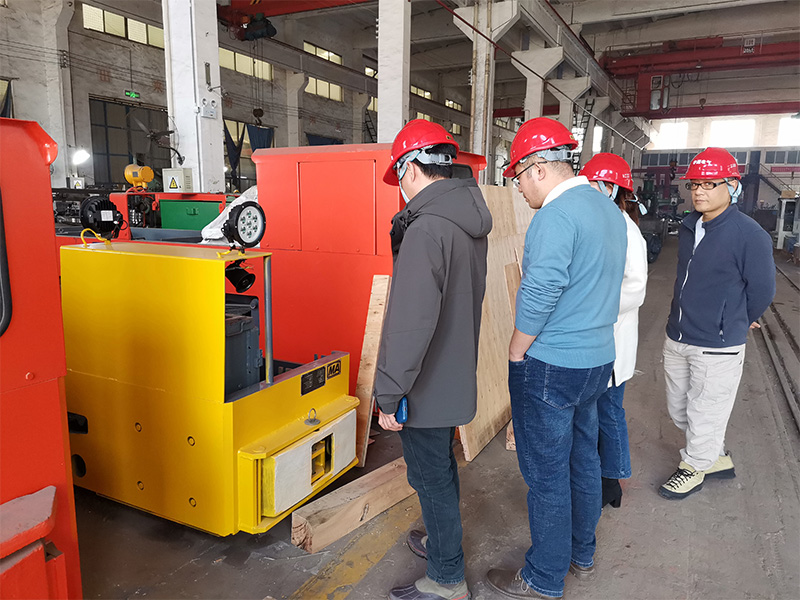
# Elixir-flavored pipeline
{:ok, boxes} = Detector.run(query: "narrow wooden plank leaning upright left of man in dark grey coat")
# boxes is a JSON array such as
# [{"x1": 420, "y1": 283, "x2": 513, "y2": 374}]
[{"x1": 356, "y1": 275, "x2": 392, "y2": 467}]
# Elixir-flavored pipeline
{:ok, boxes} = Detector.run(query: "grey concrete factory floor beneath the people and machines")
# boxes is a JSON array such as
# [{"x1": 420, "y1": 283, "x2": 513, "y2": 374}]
[{"x1": 76, "y1": 238, "x2": 800, "y2": 600}]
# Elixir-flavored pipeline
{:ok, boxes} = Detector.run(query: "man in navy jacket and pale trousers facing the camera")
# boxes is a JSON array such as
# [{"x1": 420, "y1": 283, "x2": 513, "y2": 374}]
[{"x1": 658, "y1": 148, "x2": 775, "y2": 500}]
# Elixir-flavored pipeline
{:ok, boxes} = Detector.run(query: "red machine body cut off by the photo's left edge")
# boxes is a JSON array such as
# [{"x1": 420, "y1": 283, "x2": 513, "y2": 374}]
[{"x1": 0, "y1": 119, "x2": 82, "y2": 598}]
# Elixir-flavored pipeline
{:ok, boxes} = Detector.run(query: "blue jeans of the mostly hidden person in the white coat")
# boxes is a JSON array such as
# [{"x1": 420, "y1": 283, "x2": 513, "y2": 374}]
[{"x1": 597, "y1": 381, "x2": 631, "y2": 479}]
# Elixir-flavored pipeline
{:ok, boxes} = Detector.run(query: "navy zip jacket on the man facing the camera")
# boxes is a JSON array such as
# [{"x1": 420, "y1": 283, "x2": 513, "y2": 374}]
[{"x1": 667, "y1": 204, "x2": 775, "y2": 348}]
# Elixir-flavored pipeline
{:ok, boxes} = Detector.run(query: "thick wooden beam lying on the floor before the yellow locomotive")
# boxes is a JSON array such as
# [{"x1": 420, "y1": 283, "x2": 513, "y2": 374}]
[{"x1": 292, "y1": 458, "x2": 414, "y2": 552}]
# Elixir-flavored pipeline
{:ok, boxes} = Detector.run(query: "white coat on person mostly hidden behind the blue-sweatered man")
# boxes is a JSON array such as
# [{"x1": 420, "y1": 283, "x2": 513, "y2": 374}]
[{"x1": 608, "y1": 212, "x2": 647, "y2": 387}]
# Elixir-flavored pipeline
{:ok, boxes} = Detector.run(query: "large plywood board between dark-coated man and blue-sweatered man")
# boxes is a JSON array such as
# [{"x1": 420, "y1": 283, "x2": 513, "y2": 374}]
[{"x1": 459, "y1": 186, "x2": 534, "y2": 461}]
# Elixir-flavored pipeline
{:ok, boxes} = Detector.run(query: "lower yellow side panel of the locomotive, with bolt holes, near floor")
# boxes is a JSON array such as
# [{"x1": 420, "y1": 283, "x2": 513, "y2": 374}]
[{"x1": 67, "y1": 373, "x2": 238, "y2": 535}]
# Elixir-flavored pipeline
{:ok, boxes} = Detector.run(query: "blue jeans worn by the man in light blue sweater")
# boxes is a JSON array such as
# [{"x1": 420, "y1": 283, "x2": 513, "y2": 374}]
[{"x1": 508, "y1": 355, "x2": 614, "y2": 596}]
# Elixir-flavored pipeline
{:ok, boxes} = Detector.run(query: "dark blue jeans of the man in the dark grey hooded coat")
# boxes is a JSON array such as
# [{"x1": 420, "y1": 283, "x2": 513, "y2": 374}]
[{"x1": 400, "y1": 426, "x2": 464, "y2": 584}]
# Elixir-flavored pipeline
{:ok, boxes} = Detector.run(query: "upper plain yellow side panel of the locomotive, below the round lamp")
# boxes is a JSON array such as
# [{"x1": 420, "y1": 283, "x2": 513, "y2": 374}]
[{"x1": 61, "y1": 244, "x2": 225, "y2": 403}]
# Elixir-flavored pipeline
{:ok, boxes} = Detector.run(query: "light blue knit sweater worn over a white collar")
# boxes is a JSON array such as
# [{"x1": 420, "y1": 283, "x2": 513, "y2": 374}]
[{"x1": 516, "y1": 185, "x2": 628, "y2": 369}]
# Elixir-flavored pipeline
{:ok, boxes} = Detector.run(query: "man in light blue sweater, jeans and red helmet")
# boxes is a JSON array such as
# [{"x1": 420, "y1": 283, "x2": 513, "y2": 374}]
[{"x1": 487, "y1": 118, "x2": 627, "y2": 598}]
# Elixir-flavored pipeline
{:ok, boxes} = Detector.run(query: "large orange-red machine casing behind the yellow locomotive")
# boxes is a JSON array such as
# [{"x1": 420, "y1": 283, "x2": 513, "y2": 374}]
[{"x1": 253, "y1": 144, "x2": 486, "y2": 393}]
